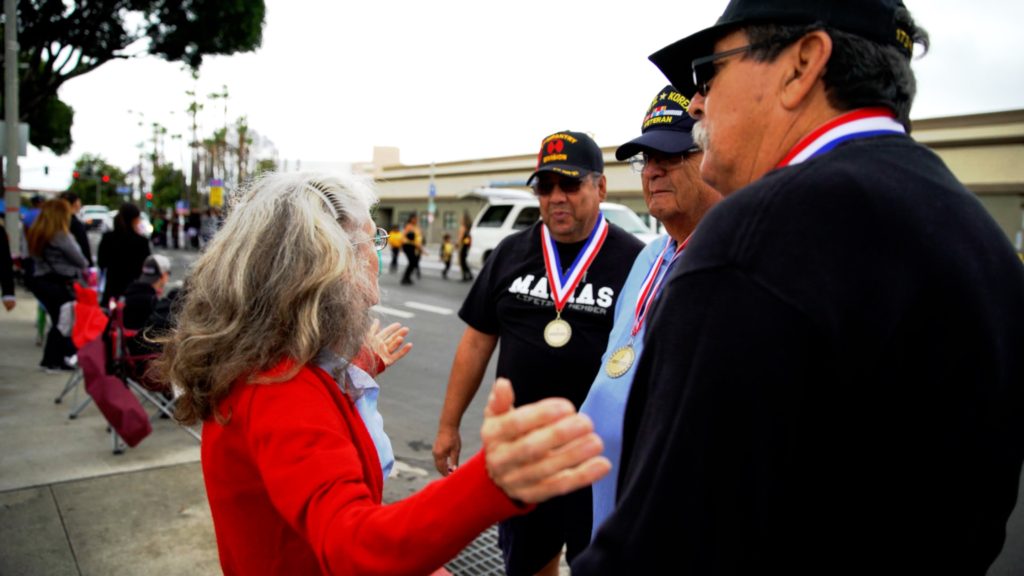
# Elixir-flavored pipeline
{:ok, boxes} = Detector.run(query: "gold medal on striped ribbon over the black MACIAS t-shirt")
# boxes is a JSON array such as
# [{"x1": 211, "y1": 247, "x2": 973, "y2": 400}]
[{"x1": 541, "y1": 212, "x2": 608, "y2": 348}]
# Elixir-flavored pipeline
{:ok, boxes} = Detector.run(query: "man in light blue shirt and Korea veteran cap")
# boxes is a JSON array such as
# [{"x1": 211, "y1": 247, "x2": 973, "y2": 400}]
[{"x1": 580, "y1": 85, "x2": 722, "y2": 532}]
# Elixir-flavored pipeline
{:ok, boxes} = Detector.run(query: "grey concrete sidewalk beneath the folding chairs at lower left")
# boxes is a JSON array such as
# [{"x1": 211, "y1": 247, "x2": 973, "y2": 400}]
[{"x1": 0, "y1": 287, "x2": 220, "y2": 576}]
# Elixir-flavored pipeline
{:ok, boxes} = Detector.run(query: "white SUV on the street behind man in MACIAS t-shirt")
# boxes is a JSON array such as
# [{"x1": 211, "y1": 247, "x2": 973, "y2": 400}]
[{"x1": 468, "y1": 191, "x2": 657, "y2": 269}]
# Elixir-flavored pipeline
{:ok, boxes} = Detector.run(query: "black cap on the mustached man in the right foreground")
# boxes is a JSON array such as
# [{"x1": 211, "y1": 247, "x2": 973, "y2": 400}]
[{"x1": 649, "y1": 0, "x2": 913, "y2": 96}]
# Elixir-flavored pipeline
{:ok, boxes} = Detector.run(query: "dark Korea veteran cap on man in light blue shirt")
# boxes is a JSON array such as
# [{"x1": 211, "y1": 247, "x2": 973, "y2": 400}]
[{"x1": 615, "y1": 84, "x2": 694, "y2": 160}]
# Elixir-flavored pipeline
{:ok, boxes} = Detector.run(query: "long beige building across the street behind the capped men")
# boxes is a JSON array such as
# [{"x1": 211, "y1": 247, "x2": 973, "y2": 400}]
[{"x1": 356, "y1": 110, "x2": 1024, "y2": 251}]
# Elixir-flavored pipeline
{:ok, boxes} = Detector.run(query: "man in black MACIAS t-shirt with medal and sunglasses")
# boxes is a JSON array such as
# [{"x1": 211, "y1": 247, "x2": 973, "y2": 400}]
[{"x1": 433, "y1": 130, "x2": 643, "y2": 576}]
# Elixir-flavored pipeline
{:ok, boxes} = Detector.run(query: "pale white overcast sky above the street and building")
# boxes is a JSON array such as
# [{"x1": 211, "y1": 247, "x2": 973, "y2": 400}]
[{"x1": 20, "y1": 0, "x2": 1024, "y2": 190}]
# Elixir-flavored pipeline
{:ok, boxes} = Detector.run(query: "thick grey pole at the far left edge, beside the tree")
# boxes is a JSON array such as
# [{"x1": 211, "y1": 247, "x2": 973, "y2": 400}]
[{"x1": 3, "y1": 0, "x2": 22, "y2": 248}]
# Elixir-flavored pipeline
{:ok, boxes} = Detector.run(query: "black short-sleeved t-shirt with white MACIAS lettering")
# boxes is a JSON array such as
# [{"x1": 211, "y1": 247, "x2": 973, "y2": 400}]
[{"x1": 459, "y1": 217, "x2": 643, "y2": 408}]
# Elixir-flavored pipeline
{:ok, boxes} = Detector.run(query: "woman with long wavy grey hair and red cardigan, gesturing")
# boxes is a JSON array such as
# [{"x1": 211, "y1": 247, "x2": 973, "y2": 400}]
[{"x1": 160, "y1": 173, "x2": 609, "y2": 574}]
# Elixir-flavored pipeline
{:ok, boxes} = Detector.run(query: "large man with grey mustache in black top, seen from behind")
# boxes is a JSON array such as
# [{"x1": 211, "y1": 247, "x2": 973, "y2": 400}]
[{"x1": 572, "y1": 0, "x2": 1024, "y2": 576}]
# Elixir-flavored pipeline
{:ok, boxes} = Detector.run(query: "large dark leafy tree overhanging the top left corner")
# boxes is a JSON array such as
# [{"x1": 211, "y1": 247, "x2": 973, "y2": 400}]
[{"x1": 0, "y1": 0, "x2": 266, "y2": 154}]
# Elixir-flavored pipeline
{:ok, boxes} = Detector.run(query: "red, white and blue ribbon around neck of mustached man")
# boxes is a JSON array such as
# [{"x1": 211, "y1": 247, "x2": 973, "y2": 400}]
[{"x1": 775, "y1": 108, "x2": 906, "y2": 168}]
